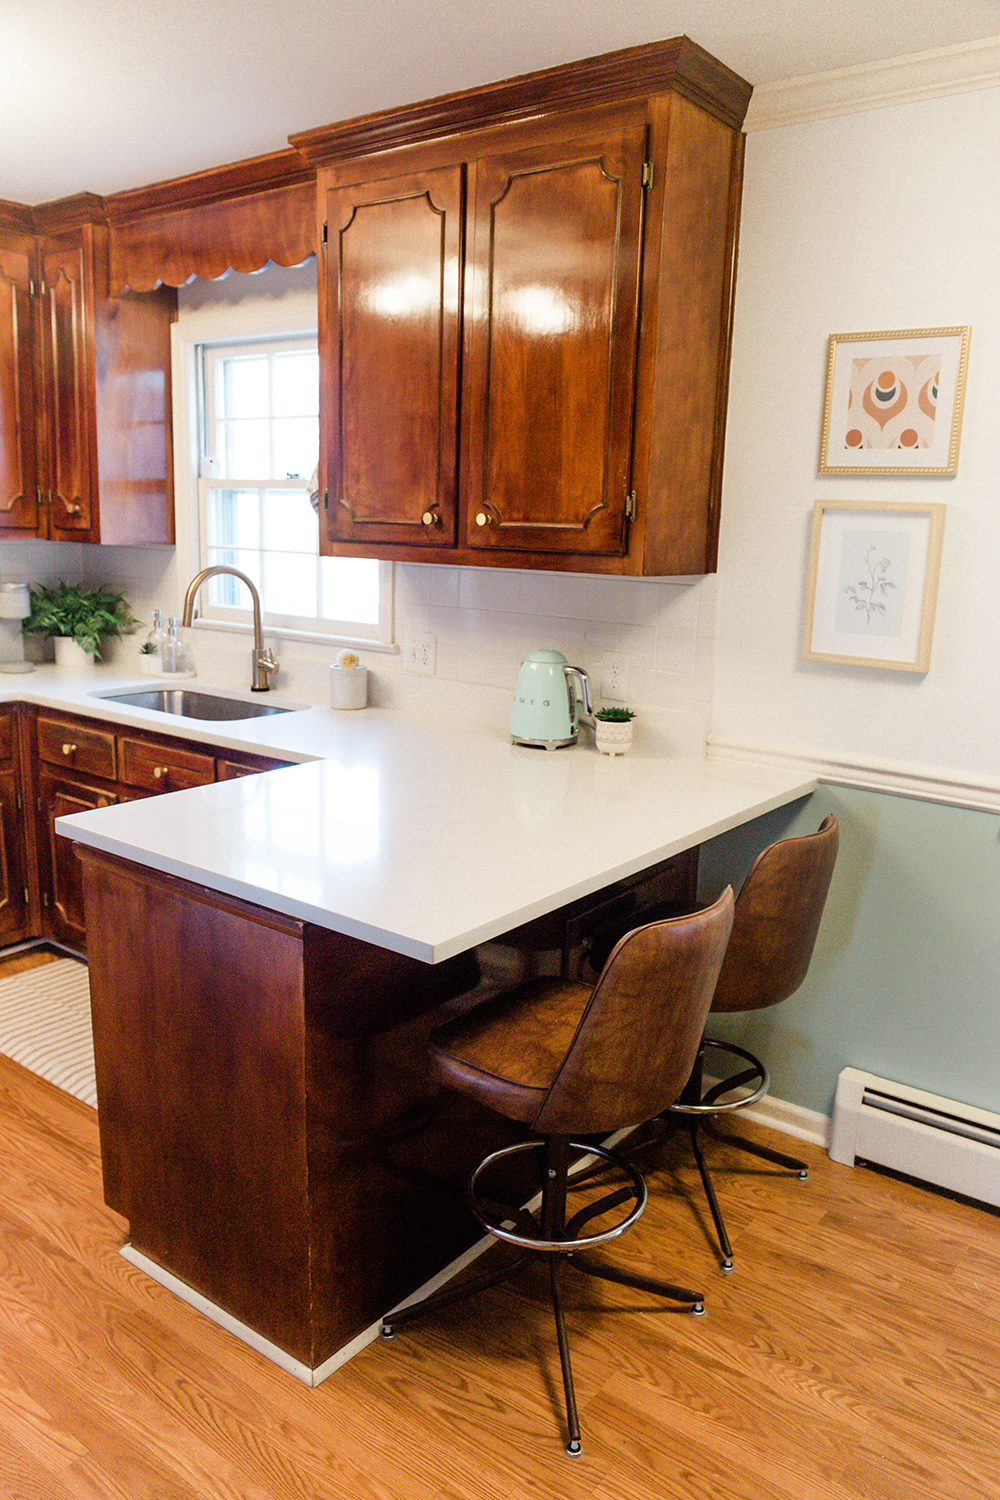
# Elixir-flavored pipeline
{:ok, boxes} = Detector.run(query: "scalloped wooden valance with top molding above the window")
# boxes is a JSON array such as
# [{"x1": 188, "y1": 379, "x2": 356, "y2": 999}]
[{"x1": 105, "y1": 152, "x2": 316, "y2": 296}]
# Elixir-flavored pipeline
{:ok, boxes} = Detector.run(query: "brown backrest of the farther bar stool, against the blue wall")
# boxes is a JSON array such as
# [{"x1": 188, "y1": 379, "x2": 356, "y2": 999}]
[{"x1": 712, "y1": 813, "x2": 840, "y2": 1013}]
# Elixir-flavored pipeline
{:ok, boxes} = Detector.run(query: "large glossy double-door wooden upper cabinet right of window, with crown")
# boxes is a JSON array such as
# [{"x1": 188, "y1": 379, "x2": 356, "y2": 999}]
[{"x1": 301, "y1": 38, "x2": 750, "y2": 576}]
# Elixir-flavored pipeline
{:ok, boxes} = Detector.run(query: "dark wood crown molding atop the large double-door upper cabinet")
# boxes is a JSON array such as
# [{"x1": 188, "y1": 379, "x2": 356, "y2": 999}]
[{"x1": 289, "y1": 36, "x2": 751, "y2": 162}]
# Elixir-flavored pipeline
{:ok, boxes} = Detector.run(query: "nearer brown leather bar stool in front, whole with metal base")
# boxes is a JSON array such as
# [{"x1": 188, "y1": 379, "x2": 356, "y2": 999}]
[{"x1": 382, "y1": 888, "x2": 733, "y2": 1455}]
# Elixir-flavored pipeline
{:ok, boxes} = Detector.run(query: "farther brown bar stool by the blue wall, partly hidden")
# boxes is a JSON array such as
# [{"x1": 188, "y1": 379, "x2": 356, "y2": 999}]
[{"x1": 669, "y1": 813, "x2": 840, "y2": 1272}]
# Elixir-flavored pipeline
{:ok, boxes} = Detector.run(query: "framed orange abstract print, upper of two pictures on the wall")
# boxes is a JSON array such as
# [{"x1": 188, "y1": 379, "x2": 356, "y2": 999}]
[{"x1": 819, "y1": 327, "x2": 972, "y2": 476}]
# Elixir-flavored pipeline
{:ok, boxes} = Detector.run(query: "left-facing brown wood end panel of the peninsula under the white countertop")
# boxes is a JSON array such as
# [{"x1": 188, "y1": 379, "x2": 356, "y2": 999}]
[{"x1": 82, "y1": 851, "x2": 312, "y2": 1364}]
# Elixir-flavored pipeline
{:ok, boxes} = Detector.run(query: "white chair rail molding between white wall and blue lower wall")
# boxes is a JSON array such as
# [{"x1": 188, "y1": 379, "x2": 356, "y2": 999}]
[{"x1": 708, "y1": 735, "x2": 1000, "y2": 813}]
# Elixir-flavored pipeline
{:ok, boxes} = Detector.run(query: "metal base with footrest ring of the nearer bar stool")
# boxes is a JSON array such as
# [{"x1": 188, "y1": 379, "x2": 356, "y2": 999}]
[{"x1": 381, "y1": 1136, "x2": 705, "y2": 1458}]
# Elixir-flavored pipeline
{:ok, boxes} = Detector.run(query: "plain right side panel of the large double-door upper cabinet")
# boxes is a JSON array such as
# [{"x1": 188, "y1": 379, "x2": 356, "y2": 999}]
[{"x1": 634, "y1": 96, "x2": 742, "y2": 575}]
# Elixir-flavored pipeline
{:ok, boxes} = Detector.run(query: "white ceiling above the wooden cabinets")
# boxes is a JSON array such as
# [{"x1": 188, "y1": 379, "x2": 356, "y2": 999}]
[{"x1": 0, "y1": 0, "x2": 1000, "y2": 203}]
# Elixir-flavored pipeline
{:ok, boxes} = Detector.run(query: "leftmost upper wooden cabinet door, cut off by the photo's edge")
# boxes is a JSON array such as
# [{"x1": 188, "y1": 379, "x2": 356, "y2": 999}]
[{"x1": 0, "y1": 245, "x2": 37, "y2": 531}]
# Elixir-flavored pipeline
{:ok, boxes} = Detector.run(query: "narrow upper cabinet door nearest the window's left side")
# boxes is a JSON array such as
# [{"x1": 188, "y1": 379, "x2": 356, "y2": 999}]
[{"x1": 42, "y1": 243, "x2": 96, "y2": 533}]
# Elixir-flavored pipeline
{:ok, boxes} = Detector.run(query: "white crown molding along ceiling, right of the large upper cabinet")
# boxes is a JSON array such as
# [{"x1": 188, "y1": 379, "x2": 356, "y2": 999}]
[{"x1": 744, "y1": 36, "x2": 1000, "y2": 134}]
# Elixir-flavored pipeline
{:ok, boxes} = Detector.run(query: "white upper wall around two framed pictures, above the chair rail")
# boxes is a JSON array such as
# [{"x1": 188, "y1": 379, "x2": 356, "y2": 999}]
[{"x1": 712, "y1": 89, "x2": 1000, "y2": 777}]
